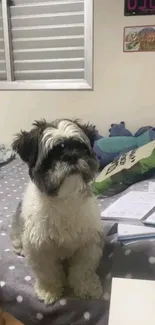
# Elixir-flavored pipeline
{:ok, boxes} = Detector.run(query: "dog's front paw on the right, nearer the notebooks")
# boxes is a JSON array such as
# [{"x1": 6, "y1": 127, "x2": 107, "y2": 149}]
[{"x1": 69, "y1": 274, "x2": 103, "y2": 299}]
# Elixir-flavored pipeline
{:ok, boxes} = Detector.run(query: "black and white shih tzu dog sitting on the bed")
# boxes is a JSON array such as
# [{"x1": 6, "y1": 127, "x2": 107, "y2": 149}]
[{"x1": 12, "y1": 119, "x2": 103, "y2": 304}]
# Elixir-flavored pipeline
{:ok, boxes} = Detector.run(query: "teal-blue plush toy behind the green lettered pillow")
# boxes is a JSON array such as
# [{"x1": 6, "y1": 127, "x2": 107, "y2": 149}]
[{"x1": 93, "y1": 122, "x2": 155, "y2": 167}]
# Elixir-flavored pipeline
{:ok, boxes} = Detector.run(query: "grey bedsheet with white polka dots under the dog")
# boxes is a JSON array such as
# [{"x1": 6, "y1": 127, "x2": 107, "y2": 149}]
[{"x1": 0, "y1": 159, "x2": 155, "y2": 325}]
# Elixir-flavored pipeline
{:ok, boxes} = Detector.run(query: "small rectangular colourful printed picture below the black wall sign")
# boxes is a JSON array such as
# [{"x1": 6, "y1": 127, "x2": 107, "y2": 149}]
[{"x1": 123, "y1": 25, "x2": 155, "y2": 52}]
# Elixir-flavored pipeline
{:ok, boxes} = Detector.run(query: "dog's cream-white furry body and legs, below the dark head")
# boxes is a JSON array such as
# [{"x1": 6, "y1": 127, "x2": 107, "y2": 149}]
[{"x1": 12, "y1": 119, "x2": 103, "y2": 303}]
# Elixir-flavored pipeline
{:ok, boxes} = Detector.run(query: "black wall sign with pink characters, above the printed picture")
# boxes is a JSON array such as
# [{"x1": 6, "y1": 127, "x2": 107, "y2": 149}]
[{"x1": 124, "y1": 0, "x2": 155, "y2": 16}]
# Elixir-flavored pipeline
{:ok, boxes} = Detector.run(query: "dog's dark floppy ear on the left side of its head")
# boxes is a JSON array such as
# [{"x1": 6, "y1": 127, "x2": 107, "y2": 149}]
[{"x1": 12, "y1": 129, "x2": 38, "y2": 167}]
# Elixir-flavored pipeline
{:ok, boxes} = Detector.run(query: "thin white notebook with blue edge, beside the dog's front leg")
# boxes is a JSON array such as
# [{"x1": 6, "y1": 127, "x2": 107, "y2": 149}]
[{"x1": 117, "y1": 223, "x2": 155, "y2": 242}]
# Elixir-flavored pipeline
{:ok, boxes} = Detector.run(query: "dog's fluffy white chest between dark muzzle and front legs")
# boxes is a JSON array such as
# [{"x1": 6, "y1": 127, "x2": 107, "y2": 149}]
[{"x1": 22, "y1": 178, "x2": 101, "y2": 255}]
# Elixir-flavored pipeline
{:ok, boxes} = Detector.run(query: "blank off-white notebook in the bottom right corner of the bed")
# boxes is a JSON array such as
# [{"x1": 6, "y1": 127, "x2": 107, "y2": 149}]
[{"x1": 108, "y1": 278, "x2": 155, "y2": 325}]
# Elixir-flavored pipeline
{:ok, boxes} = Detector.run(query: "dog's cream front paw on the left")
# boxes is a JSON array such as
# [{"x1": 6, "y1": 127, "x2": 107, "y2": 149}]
[{"x1": 35, "y1": 282, "x2": 63, "y2": 305}]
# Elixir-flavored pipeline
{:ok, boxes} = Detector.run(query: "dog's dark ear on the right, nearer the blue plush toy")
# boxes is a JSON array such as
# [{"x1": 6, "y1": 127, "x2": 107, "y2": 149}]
[{"x1": 74, "y1": 120, "x2": 98, "y2": 147}]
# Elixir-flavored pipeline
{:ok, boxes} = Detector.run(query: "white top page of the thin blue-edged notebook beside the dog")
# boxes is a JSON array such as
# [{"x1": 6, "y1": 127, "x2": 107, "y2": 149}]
[{"x1": 117, "y1": 223, "x2": 155, "y2": 238}]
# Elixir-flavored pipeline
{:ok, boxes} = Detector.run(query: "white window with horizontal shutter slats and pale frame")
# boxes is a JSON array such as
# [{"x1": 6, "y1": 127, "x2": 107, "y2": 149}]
[{"x1": 0, "y1": 0, "x2": 93, "y2": 89}]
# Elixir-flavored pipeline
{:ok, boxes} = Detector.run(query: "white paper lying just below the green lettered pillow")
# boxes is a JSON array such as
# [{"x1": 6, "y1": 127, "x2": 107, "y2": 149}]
[{"x1": 101, "y1": 191, "x2": 155, "y2": 220}]
